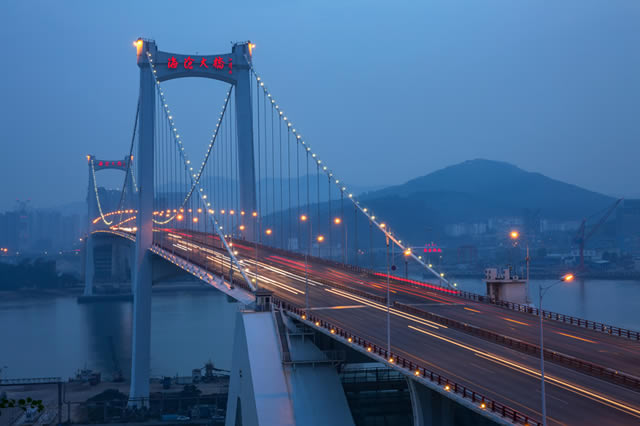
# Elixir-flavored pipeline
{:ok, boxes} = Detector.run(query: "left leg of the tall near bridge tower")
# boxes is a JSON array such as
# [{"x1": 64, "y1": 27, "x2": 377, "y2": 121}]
[{"x1": 129, "y1": 42, "x2": 155, "y2": 406}]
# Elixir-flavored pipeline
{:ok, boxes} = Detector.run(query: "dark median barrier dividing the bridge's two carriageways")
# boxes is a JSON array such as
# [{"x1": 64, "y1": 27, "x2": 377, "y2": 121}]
[{"x1": 393, "y1": 302, "x2": 640, "y2": 391}]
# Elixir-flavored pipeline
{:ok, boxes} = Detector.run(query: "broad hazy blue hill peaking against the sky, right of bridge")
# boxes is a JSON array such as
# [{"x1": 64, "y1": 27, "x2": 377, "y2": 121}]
[{"x1": 361, "y1": 159, "x2": 614, "y2": 224}]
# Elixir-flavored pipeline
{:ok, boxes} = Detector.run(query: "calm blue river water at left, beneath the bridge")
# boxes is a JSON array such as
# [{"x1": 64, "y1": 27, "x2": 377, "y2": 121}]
[{"x1": 0, "y1": 290, "x2": 238, "y2": 379}]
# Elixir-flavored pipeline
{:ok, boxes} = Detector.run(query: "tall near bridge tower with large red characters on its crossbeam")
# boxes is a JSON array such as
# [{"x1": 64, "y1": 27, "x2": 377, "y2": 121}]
[{"x1": 129, "y1": 39, "x2": 257, "y2": 405}]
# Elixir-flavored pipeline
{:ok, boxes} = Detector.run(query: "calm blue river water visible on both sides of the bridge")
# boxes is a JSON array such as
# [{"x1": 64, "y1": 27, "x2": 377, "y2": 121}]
[{"x1": 0, "y1": 279, "x2": 640, "y2": 378}]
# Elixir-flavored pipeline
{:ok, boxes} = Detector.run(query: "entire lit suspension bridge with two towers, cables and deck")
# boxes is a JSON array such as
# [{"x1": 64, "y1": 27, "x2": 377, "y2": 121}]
[{"x1": 85, "y1": 39, "x2": 640, "y2": 424}]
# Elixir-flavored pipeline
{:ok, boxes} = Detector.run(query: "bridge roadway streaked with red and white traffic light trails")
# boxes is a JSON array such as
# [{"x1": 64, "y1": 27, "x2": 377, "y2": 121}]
[{"x1": 149, "y1": 230, "x2": 640, "y2": 425}]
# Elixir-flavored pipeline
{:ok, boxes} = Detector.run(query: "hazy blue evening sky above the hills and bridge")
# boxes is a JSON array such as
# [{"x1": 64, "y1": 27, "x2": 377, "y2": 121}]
[{"x1": 0, "y1": 0, "x2": 640, "y2": 209}]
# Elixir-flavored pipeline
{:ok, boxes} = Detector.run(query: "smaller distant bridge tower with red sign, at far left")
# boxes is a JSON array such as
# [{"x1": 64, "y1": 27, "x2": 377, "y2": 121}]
[{"x1": 84, "y1": 155, "x2": 134, "y2": 296}]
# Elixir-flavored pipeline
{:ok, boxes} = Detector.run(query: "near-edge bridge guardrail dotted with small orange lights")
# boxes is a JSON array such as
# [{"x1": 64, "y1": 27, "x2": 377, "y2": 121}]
[{"x1": 273, "y1": 297, "x2": 542, "y2": 426}]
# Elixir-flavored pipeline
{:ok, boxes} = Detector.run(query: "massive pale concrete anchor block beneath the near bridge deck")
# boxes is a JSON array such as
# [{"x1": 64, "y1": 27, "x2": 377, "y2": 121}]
[{"x1": 225, "y1": 311, "x2": 354, "y2": 426}]
